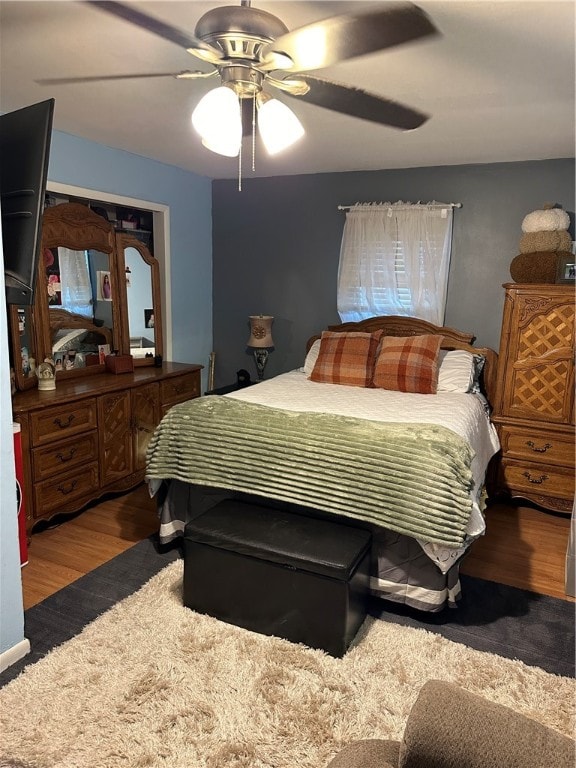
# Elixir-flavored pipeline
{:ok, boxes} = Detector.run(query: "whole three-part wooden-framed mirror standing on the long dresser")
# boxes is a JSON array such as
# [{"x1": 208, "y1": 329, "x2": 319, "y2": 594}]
[{"x1": 9, "y1": 203, "x2": 162, "y2": 390}]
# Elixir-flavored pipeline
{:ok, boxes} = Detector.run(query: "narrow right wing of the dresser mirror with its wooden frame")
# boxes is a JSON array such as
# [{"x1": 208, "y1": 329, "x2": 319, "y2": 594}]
[{"x1": 116, "y1": 233, "x2": 163, "y2": 365}]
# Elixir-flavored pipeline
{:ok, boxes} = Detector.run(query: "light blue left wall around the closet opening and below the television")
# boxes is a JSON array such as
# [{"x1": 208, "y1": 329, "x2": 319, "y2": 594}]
[{"x1": 0, "y1": 131, "x2": 212, "y2": 653}]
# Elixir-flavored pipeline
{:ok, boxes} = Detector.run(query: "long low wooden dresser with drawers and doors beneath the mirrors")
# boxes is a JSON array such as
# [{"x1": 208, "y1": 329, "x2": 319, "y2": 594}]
[{"x1": 12, "y1": 363, "x2": 202, "y2": 530}]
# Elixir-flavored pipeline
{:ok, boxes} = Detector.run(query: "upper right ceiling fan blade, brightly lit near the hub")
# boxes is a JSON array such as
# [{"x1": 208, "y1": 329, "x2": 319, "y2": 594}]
[{"x1": 260, "y1": 3, "x2": 438, "y2": 71}]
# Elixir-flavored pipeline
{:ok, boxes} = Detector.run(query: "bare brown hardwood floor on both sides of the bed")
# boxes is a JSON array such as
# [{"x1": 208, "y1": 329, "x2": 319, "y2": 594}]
[{"x1": 22, "y1": 485, "x2": 574, "y2": 609}]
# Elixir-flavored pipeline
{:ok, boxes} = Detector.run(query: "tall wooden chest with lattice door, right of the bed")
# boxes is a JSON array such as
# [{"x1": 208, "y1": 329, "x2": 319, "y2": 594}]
[{"x1": 493, "y1": 283, "x2": 574, "y2": 513}]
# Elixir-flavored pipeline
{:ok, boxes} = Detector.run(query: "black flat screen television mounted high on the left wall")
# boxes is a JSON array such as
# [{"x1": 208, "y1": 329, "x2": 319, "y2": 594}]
[{"x1": 0, "y1": 99, "x2": 54, "y2": 306}]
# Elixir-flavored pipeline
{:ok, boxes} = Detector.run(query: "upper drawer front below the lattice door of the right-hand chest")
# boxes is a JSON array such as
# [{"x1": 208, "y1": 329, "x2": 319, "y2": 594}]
[{"x1": 500, "y1": 427, "x2": 574, "y2": 467}]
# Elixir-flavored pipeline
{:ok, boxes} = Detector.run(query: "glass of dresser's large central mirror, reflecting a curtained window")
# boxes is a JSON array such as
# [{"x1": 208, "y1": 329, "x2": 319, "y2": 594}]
[{"x1": 43, "y1": 247, "x2": 114, "y2": 370}]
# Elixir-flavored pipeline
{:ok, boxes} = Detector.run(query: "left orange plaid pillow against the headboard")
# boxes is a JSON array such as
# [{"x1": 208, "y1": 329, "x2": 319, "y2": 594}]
[{"x1": 310, "y1": 331, "x2": 382, "y2": 387}]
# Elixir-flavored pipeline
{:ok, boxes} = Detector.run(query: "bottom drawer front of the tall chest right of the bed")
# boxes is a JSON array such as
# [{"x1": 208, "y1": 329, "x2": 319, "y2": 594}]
[{"x1": 500, "y1": 459, "x2": 574, "y2": 500}]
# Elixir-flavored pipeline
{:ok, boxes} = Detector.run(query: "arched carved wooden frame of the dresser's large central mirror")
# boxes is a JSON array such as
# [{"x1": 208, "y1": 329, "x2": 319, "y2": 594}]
[{"x1": 34, "y1": 203, "x2": 125, "y2": 378}]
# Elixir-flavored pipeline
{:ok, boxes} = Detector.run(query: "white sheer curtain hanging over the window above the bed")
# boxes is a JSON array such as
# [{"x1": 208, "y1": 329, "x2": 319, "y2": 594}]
[{"x1": 338, "y1": 202, "x2": 453, "y2": 325}]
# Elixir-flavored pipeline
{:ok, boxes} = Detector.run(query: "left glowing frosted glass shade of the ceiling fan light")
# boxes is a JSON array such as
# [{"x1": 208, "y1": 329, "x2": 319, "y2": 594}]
[{"x1": 192, "y1": 85, "x2": 242, "y2": 157}]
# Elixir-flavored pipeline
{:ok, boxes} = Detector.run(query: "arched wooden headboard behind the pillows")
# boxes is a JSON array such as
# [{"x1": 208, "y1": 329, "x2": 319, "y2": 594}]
[{"x1": 306, "y1": 315, "x2": 498, "y2": 404}]
